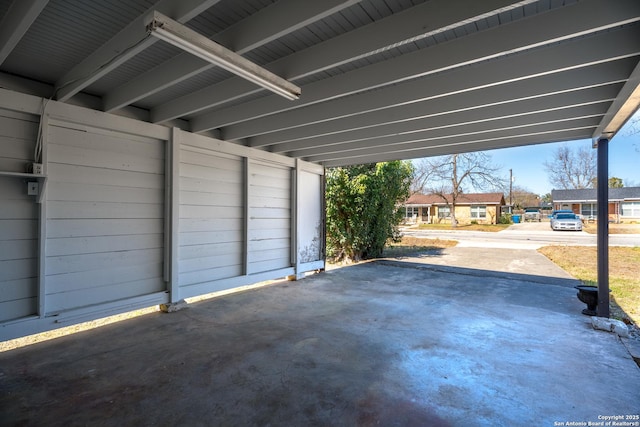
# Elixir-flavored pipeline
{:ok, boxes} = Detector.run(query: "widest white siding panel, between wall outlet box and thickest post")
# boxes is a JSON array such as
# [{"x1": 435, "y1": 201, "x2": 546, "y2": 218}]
[{"x1": 45, "y1": 126, "x2": 166, "y2": 314}]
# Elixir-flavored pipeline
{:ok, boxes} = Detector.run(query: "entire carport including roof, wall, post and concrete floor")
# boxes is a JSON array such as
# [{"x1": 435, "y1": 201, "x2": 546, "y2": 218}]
[{"x1": 0, "y1": 0, "x2": 640, "y2": 425}]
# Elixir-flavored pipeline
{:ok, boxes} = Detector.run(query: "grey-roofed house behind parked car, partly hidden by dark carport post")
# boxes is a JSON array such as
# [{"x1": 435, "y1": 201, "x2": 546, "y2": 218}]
[{"x1": 551, "y1": 187, "x2": 640, "y2": 222}]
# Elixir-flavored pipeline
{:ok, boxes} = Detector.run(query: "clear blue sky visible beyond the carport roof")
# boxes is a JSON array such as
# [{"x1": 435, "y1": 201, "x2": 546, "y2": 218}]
[{"x1": 486, "y1": 111, "x2": 640, "y2": 195}]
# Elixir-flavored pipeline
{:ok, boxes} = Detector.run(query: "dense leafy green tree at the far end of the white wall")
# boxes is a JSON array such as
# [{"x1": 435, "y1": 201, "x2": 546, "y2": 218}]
[{"x1": 326, "y1": 161, "x2": 413, "y2": 261}]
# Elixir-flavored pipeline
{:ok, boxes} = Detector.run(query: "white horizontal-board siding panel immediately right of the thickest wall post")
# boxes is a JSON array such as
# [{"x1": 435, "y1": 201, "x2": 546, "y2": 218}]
[{"x1": 178, "y1": 146, "x2": 244, "y2": 288}]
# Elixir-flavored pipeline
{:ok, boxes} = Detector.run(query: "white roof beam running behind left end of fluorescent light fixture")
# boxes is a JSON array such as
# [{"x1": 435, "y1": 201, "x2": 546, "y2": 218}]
[{"x1": 55, "y1": 0, "x2": 220, "y2": 101}]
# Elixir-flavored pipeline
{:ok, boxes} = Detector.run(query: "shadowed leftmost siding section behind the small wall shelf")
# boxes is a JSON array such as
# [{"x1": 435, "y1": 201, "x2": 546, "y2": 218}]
[{"x1": 0, "y1": 109, "x2": 38, "y2": 322}]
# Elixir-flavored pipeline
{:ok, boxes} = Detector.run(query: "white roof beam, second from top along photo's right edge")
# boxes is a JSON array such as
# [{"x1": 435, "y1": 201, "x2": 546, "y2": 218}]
[{"x1": 218, "y1": 25, "x2": 640, "y2": 140}]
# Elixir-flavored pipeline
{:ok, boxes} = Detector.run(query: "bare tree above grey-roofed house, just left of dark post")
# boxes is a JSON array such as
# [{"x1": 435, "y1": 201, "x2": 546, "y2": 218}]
[{"x1": 544, "y1": 144, "x2": 598, "y2": 190}]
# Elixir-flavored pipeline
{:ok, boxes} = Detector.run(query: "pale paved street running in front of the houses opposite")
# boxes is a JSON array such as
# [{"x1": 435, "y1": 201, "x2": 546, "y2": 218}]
[{"x1": 403, "y1": 222, "x2": 640, "y2": 249}]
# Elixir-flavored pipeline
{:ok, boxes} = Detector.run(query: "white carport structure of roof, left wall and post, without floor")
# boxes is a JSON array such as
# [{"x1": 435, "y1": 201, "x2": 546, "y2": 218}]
[{"x1": 0, "y1": 0, "x2": 640, "y2": 398}]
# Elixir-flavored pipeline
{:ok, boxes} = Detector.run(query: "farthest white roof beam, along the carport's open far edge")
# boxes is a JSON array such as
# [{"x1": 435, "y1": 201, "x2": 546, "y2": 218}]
[{"x1": 322, "y1": 129, "x2": 588, "y2": 167}]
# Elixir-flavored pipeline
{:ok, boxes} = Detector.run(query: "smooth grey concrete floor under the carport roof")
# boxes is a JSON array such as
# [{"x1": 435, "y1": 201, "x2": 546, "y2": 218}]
[{"x1": 0, "y1": 254, "x2": 640, "y2": 426}]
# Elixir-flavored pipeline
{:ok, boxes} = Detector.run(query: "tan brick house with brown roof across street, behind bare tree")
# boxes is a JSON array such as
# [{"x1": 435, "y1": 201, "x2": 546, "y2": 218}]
[{"x1": 404, "y1": 193, "x2": 505, "y2": 224}]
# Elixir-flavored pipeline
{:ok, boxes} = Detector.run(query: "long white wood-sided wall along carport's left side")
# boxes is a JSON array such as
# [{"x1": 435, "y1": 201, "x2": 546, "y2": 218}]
[{"x1": 0, "y1": 89, "x2": 324, "y2": 340}]
